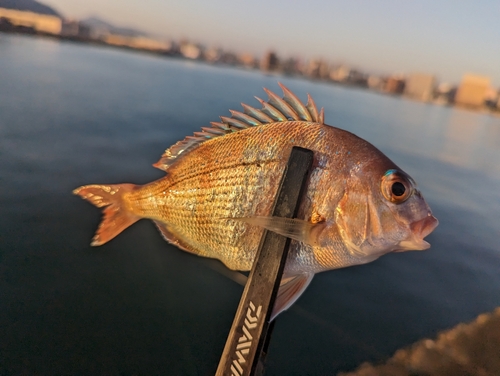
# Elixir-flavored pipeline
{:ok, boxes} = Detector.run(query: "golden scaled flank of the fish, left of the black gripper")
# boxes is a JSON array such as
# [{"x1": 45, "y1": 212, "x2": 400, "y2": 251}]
[{"x1": 125, "y1": 122, "x2": 324, "y2": 270}]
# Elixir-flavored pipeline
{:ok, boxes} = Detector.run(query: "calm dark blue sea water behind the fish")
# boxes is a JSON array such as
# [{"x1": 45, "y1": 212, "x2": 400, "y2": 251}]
[{"x1": 0, "y1": 34, "x2": 500, "y2": 375}]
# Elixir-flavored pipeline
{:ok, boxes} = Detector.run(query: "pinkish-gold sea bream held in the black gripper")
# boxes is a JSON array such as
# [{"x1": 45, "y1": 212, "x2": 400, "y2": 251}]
[{"x1": 74, "y1": 83, "x2": 438, "y2": 318}]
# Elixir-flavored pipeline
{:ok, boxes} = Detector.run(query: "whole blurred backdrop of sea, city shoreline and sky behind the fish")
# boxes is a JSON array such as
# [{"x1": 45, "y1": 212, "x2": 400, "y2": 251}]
[{"x1": 0, "y1": 0, "x2": 500, "y2": 375}]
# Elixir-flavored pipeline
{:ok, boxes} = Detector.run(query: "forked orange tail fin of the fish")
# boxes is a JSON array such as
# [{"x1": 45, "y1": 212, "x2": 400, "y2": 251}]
[{"x1": 73, "y1": 184, "x2": 140, "y2": 246}]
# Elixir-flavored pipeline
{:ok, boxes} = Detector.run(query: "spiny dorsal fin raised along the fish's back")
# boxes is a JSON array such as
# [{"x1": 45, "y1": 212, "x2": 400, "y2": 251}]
[{"x1": 153, "y1": 83, "x2": 324, "y2": 171}]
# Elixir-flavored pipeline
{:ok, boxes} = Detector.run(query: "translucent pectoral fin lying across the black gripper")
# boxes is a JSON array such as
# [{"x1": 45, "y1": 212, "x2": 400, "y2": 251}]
[{"x1": 231, "y1": 216, "x2": 326, "y2": 246}]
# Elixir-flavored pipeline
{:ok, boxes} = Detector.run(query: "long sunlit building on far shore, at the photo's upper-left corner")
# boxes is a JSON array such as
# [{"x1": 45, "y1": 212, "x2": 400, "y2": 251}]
[{"x1": 0, "y1": 8, "x2": 62, "y2": 34}]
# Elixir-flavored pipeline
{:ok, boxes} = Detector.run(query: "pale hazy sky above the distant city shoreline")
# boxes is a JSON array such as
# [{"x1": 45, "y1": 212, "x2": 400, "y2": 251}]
[{"x1": 44, "y1": 0, "x2": 500, "y2": 88}]
